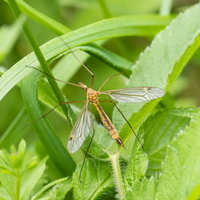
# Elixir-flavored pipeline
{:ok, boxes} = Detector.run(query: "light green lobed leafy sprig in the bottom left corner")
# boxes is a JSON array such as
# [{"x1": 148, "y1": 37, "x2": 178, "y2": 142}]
[{"x1": 0, "y1": 140, "x2": 47, "y2": 199}]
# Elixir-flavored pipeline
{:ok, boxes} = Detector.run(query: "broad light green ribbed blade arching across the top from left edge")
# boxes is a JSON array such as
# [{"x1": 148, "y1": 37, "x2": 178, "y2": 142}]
[{"x1": 0, "y1": 16, "x2": 170, "y2": 100}]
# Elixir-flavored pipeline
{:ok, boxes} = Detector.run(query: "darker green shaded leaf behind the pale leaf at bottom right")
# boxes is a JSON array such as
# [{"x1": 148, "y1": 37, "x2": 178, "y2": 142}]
[{"x1": 143, "y1": 108, "x2": 199, "y2": 176}]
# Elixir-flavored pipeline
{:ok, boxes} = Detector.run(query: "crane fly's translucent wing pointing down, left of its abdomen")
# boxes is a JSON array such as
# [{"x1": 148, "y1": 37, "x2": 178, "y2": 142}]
[{"x1": 67, "y1": 102, "x2": 92, "y2": 153}]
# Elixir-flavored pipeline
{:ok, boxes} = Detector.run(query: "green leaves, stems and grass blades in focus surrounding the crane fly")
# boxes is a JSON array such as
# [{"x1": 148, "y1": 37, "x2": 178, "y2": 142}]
[{"x1": 0, "y1": 0, "x2": 200, "y2": 200}]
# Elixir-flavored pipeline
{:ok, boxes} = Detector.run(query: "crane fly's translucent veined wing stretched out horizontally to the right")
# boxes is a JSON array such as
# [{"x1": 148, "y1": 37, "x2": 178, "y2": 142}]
[{"x1": 101, "y1": 87, "x2": 164, "y2": 103}]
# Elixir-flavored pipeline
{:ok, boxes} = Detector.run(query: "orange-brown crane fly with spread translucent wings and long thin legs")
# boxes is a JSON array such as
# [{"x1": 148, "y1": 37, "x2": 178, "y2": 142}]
[{"x1": 28, "y1": 43, "x2": 164, "y2": 153}]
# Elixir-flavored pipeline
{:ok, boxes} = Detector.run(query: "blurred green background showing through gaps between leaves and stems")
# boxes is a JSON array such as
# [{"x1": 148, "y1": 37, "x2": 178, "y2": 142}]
[{"x1": 0, "y1": 0, "x2": 200, "y2": 178}]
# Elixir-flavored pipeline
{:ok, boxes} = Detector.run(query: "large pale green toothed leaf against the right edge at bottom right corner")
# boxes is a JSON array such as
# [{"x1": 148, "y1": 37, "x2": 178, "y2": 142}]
[{"x1": 156, "y1": 110, "x2": 200, "y2": 200}]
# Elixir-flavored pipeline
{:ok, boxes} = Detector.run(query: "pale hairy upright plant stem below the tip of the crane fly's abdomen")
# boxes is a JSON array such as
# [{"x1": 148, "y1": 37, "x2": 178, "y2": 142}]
[{"x1": 110, "y1": 154, "x2": 124, "y2": 199}]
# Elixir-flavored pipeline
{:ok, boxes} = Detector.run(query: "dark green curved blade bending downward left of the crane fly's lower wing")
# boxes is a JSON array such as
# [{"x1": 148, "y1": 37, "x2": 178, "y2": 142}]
[{"x1": 21, "y1": 71, "x2": 75, "y2": 175}]
